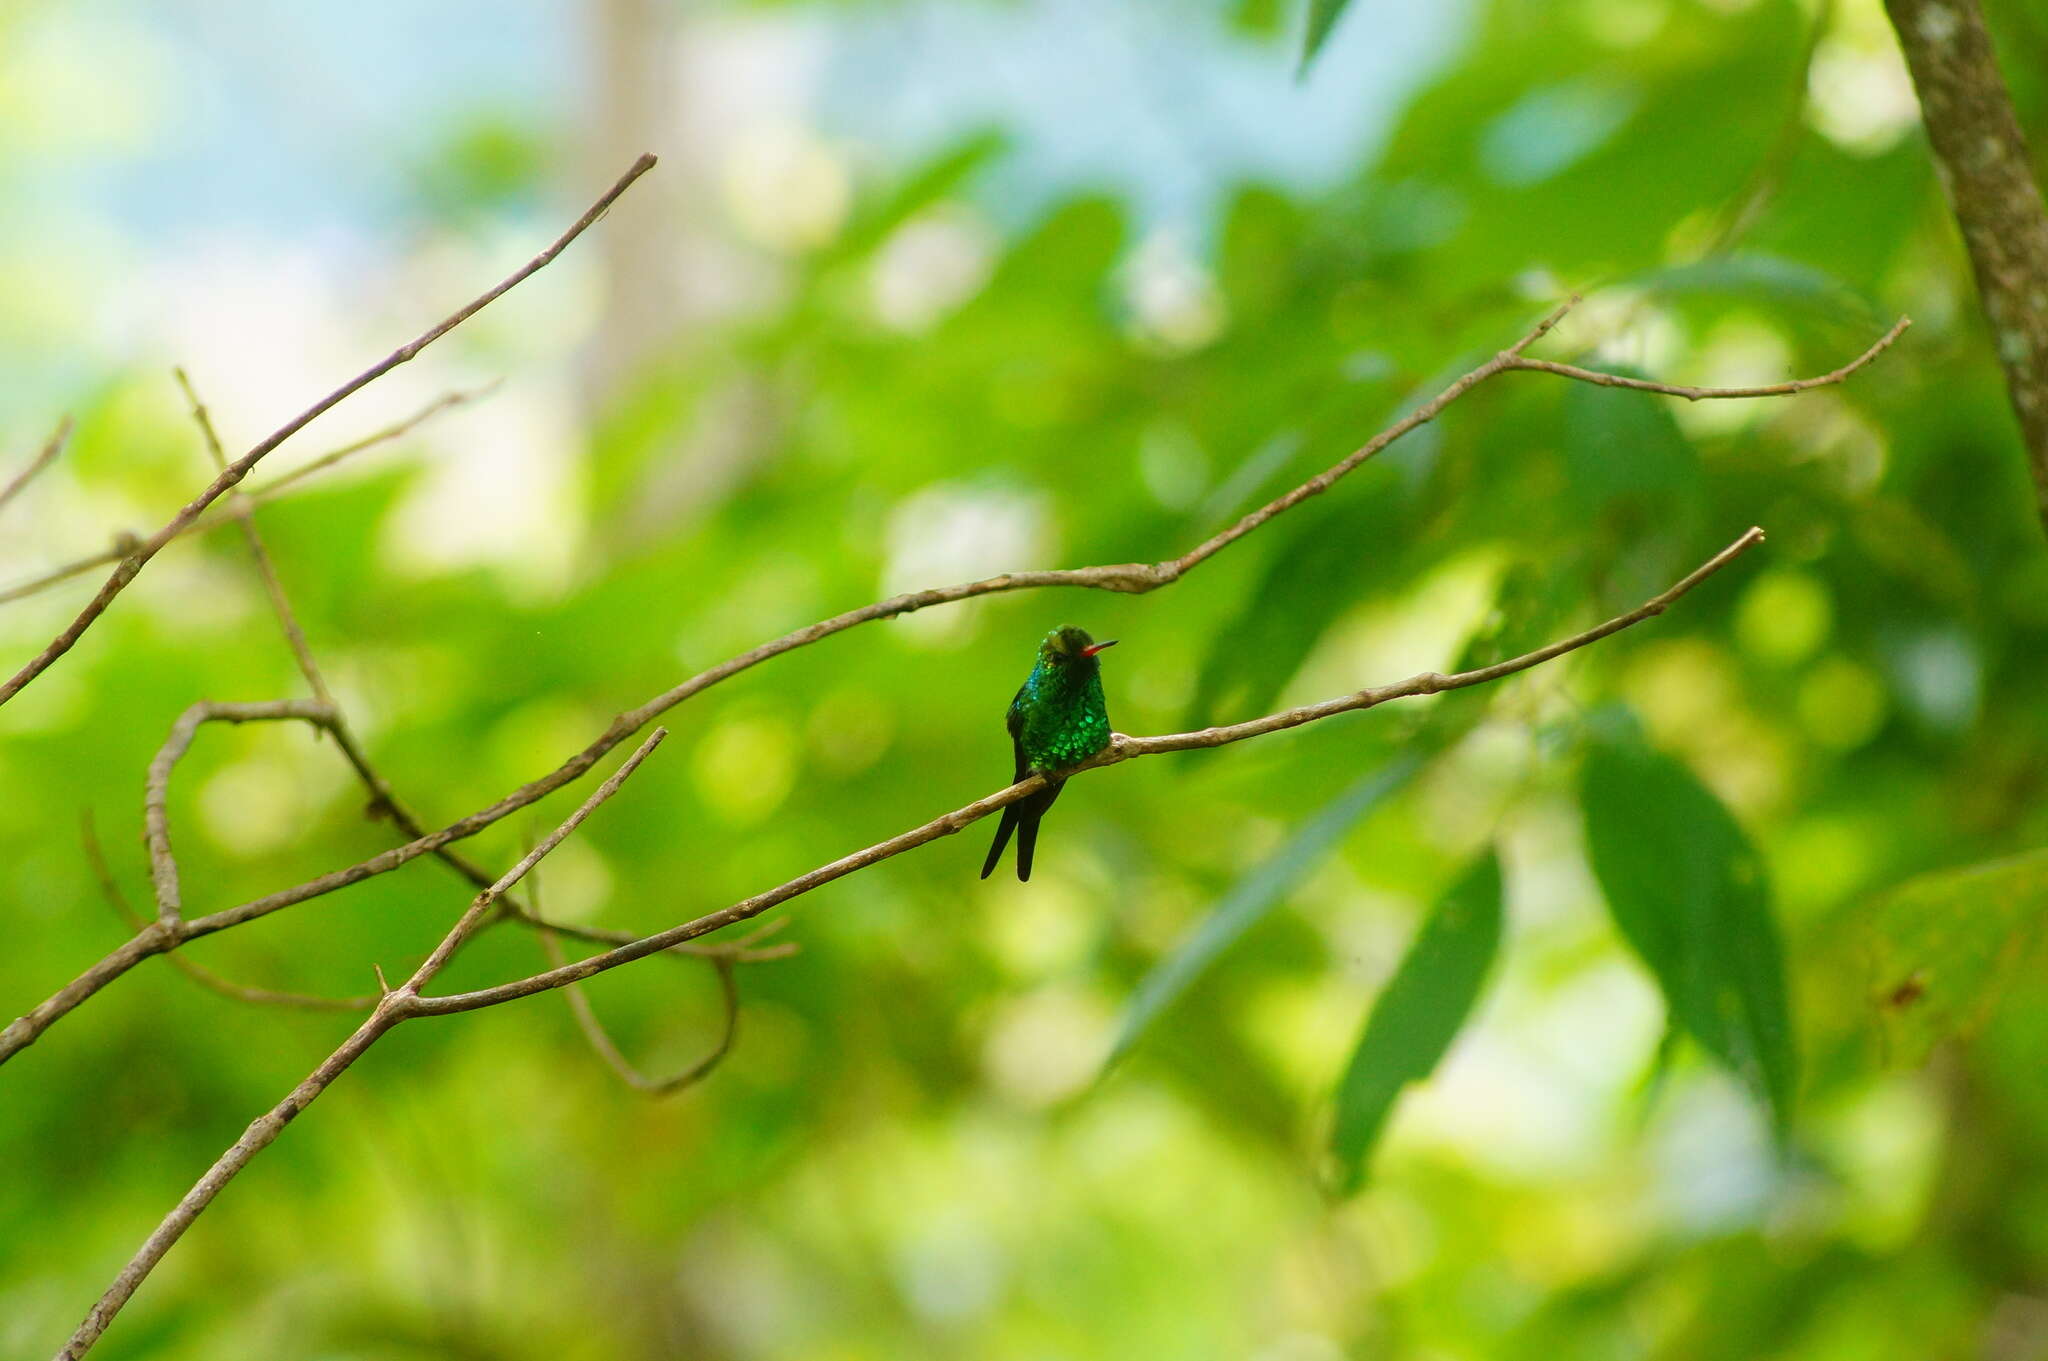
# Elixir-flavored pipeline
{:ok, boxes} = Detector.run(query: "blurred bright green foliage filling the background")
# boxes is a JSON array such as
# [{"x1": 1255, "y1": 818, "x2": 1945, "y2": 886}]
[{"x1": 0, "y1": 0, "x2": 2048, "y2": 1361}]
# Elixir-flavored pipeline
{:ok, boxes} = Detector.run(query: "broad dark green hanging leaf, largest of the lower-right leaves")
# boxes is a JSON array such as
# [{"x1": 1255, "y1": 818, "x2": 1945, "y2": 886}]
[{"x1": 1579, "y1": 731, "x2": 1798, "y2": 1138}]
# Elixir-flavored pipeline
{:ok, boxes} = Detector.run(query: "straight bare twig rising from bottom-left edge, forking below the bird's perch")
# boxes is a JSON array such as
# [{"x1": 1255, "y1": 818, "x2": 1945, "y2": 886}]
[{"x1": 57, "y1": 729, "x2": 668, "y2": 1361}]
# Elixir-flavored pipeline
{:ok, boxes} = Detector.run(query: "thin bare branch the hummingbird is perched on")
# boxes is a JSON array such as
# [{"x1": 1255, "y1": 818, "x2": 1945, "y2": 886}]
[{"x1": 414, "y1": 528, "x2": 1763, "y2": 1015}]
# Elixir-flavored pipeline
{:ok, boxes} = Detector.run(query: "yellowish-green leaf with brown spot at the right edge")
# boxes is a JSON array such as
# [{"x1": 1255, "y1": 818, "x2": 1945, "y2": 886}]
[{"x1": 1864, "y1": 851, "x2": 2048, "y2": 1064}]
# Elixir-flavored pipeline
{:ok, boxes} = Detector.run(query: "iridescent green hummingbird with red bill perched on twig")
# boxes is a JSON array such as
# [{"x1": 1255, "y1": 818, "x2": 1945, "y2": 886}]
[{"x1": 981, "y1": 624, "x2": 1116, "y2": 882}]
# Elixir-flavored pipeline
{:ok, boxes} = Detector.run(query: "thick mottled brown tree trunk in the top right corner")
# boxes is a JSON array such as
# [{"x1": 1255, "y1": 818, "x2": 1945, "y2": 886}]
[{"x1": 1884, "y1": 0, "x2": 2048, "y2": 528}]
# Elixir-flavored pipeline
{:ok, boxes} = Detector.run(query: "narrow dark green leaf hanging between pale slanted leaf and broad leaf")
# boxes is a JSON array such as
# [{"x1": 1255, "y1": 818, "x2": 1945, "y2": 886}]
[{"x1": 1329, "y1": 849, "x2": 1501, "y2": 1195}]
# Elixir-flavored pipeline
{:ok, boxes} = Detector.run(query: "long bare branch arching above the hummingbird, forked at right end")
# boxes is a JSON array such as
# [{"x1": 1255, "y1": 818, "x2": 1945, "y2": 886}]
[{"x1": 0, "y1": 297, "x2": 1909, "y2": 1062}]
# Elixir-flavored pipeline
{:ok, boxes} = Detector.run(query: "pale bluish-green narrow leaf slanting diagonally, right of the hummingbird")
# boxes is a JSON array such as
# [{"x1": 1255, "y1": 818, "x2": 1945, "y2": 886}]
[{"x1": 1102, "y1": 751, "x2": 1421, "y2": 1070}]
